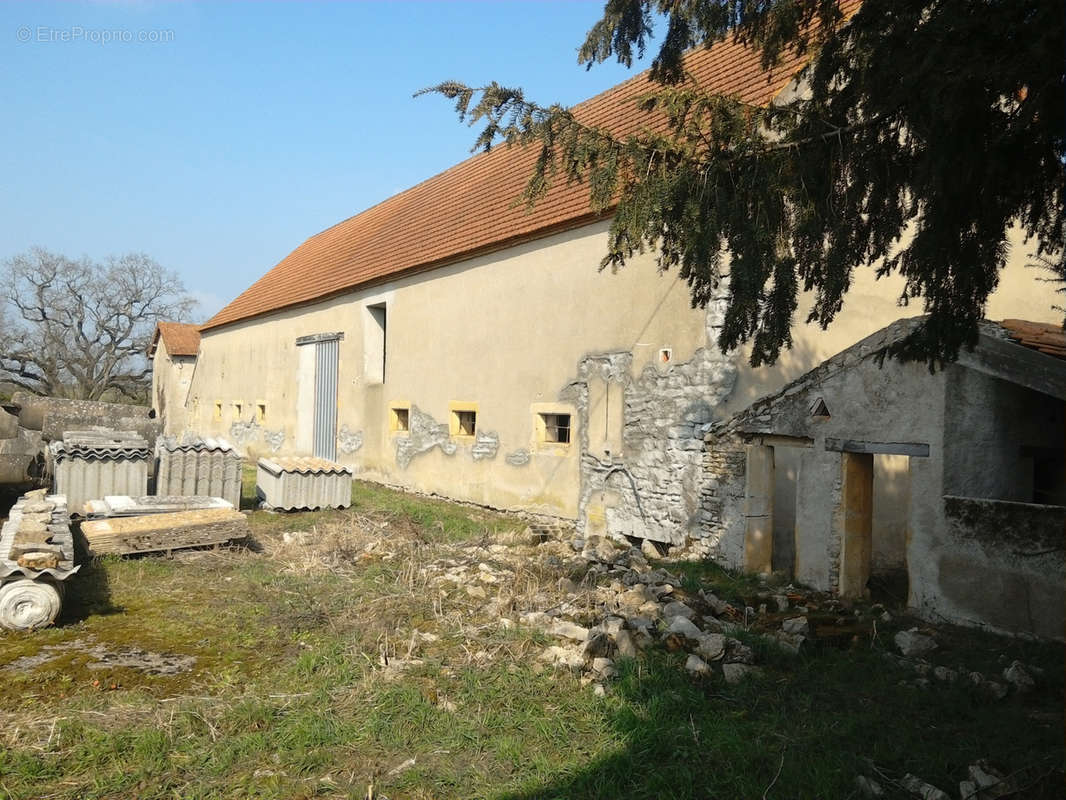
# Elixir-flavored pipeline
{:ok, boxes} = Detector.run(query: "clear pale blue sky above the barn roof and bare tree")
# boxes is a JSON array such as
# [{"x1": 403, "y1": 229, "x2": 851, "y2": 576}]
[{"x1": 0, "y1": 0, "x2": 648, "y2": 318}]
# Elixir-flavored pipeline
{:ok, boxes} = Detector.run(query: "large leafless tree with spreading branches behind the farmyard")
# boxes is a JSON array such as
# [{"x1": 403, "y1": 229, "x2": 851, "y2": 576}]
[{"x1": 0, "y1": 247, "x2": 193, "y2": 400}]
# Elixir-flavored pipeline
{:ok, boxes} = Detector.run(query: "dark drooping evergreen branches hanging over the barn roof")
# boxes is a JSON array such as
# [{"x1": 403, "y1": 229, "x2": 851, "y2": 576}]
[{"x1": 420, "y1": 0, "x2": 1066, "y2": 369}]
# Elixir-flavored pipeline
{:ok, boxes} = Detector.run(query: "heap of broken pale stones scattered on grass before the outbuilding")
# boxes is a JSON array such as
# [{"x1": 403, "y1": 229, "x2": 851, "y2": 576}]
[{"x1": 396, "y1": 522, "x2": 1035, "y2": 716}]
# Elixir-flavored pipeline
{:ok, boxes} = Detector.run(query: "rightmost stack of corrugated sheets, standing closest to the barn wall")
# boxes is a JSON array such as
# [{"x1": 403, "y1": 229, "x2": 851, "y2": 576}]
[{"x1": 256, "y1": 458, "x2": 352, "y2": 511}]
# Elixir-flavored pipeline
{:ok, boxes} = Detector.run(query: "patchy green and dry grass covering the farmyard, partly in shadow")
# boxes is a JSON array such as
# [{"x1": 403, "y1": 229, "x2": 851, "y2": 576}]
[{"x1": 0, "y1": 484, "x2": 1063, "y2": 800}]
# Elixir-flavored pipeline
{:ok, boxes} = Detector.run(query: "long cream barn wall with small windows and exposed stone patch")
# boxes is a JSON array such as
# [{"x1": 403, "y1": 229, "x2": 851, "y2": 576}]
[{"x1": 181, "y1": 216, "x2": 1052, "y2": 526}]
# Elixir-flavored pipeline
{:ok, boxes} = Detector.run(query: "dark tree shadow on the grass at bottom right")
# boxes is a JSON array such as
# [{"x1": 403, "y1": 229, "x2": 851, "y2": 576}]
[{"x1": 497, "y1": 640, "x2": 1063, "y2": 800}]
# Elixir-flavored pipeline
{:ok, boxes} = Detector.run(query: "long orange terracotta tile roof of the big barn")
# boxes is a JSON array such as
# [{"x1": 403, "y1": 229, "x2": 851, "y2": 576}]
[{"x1": 200, "y1": 9, "x2": 859, "y2": 331}]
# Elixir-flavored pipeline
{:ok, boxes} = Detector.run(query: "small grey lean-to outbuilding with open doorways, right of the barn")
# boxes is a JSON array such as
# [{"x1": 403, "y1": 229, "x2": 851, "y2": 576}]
[{"x1": 702, "y1": 320, "x2": 1066, "y2": 639}]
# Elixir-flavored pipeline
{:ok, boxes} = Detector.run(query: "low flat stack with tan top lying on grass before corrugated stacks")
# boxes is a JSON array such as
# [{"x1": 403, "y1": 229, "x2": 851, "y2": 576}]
[{"x1": 81, "y1": 509, "x2": 248, "y2": 556}]
